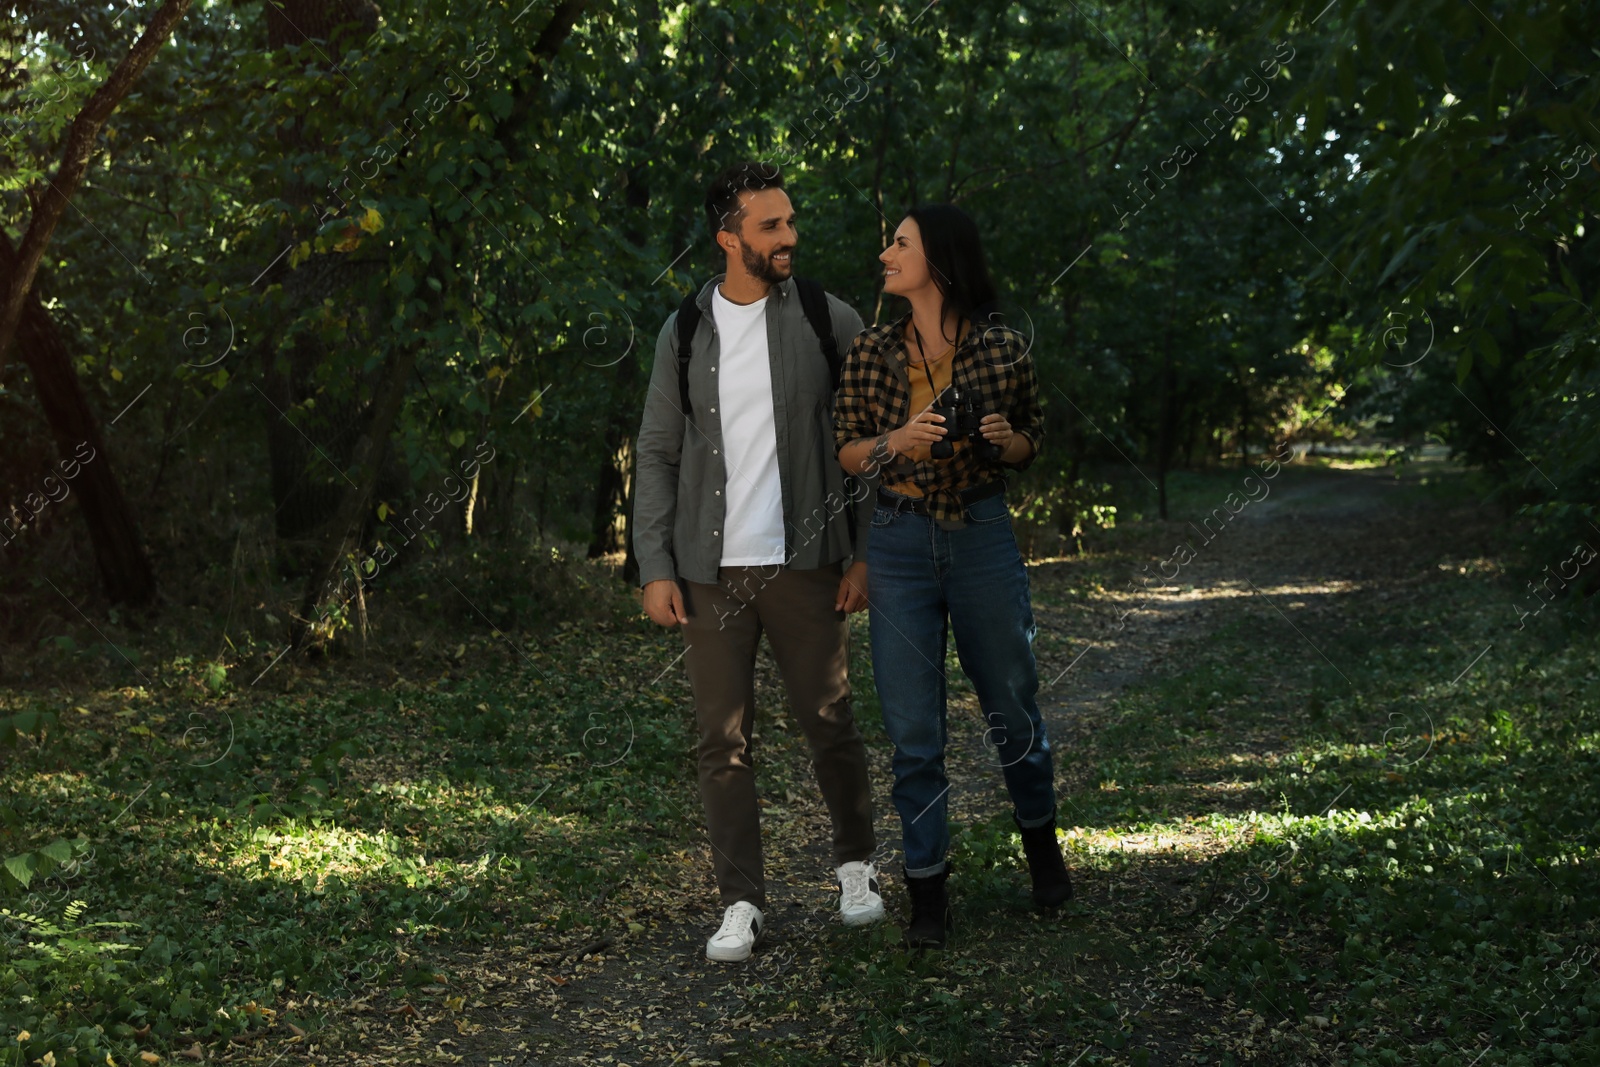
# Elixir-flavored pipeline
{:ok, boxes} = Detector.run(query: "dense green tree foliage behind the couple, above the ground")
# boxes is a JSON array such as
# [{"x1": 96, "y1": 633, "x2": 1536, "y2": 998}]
[{"x1": 5, "y1": 0, "x2": 1600, "y2": 607}]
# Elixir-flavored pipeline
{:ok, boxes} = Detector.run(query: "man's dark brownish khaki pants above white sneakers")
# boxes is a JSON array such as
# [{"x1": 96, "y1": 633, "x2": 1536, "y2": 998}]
[{"x1": 682, "y1": 563, "x2": 877, "y2": 910}]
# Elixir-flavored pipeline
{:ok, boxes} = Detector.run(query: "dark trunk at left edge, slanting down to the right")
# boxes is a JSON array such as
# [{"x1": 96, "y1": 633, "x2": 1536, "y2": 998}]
[{"x1": 0, "y1": 229, "x2": 155, "y2": 606}]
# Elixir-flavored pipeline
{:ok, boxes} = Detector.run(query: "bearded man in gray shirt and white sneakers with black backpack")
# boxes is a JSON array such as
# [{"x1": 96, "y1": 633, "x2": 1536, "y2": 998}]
[{"x1": 634, "y1": 163, "x2": 883, "y2": 961}]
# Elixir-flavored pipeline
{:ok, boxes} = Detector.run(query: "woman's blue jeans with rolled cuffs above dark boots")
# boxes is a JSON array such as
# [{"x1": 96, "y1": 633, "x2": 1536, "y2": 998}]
[{"x1": 867, "y1": 496, "x2": 1056, "y2": 878}]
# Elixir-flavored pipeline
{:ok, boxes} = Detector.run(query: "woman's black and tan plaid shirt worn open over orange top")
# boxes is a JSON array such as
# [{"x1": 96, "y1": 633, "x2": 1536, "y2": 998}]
[{"x1": 834, "y1": 312, "x2": 1045, "y2": 525}]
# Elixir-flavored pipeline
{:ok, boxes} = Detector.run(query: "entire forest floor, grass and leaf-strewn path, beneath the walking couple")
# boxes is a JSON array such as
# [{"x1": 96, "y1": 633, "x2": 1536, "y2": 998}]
[{"x1": 0, "y1": 464, "x2": 1600, "y2": 1067}]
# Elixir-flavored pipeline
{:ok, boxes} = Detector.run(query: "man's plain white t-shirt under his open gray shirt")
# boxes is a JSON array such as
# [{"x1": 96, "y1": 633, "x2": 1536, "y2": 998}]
[{"x1": 710, "y1": 285, "x2": 784, "y2": 566}]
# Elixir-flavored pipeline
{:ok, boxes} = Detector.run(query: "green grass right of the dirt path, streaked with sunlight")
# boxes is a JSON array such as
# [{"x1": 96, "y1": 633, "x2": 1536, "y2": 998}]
[{"x1": 707, "y1": 478, "x2": 1600, "y2": 1067}]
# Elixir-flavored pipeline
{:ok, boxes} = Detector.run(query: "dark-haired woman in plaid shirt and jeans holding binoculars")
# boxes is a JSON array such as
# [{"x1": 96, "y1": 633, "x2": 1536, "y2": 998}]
[{"x1": 834, "y1": 205, "x2": 1072, "y2": 947}]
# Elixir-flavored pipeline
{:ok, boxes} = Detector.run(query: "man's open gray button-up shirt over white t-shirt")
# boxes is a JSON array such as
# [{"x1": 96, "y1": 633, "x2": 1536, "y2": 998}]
[{"x1": 634, "y1": 275, "x2": 874, "y2": 585}]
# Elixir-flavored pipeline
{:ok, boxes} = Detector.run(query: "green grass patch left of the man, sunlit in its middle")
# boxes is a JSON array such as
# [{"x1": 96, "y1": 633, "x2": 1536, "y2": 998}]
[{"x1": 0, "y1": 625, "x2": 698, "y2": 1067}]
